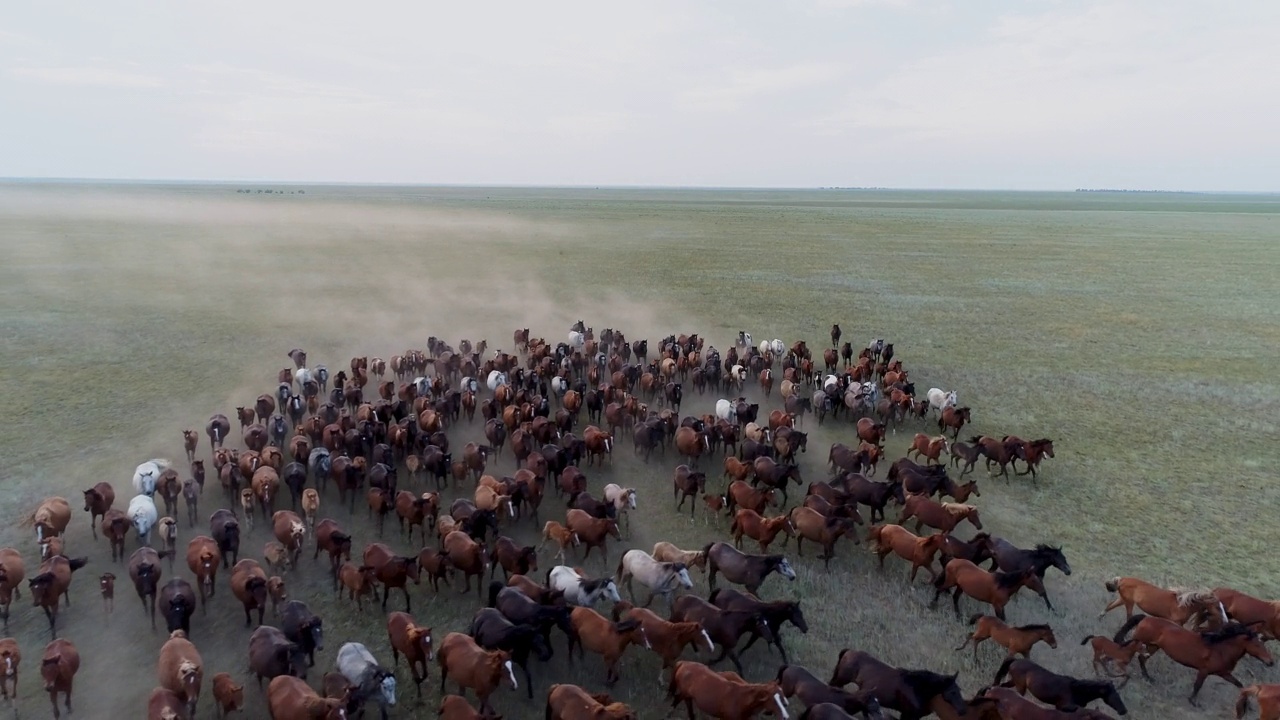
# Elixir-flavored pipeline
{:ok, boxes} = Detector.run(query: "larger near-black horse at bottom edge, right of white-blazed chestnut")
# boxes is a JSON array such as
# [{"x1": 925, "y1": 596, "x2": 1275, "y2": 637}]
[{"x1": 828, "y1": 647, "x2": 969, "y2": 720}]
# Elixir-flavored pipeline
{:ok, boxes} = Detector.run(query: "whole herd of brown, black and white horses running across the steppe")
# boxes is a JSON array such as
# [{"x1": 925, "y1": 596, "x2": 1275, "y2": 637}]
[{"x1": 0, "y1": 322, "x2": 1280, "y2": 720}]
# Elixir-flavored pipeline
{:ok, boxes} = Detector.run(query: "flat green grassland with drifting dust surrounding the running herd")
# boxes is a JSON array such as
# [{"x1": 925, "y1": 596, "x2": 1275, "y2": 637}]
[{"x1": 0, "y1": 183, "x2": 1280, "y2": 719}]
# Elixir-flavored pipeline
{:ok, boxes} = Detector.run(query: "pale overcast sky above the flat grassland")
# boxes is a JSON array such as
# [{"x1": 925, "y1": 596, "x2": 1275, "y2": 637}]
[{"x1": 0, "y1": 0, "x2": 1280, "y2": 191}]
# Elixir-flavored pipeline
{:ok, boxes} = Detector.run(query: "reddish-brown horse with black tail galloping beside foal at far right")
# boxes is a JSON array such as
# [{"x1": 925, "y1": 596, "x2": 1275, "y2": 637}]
[{"x1": 1114, "y1": 615, "x2": 1275, "y2": 705}]
